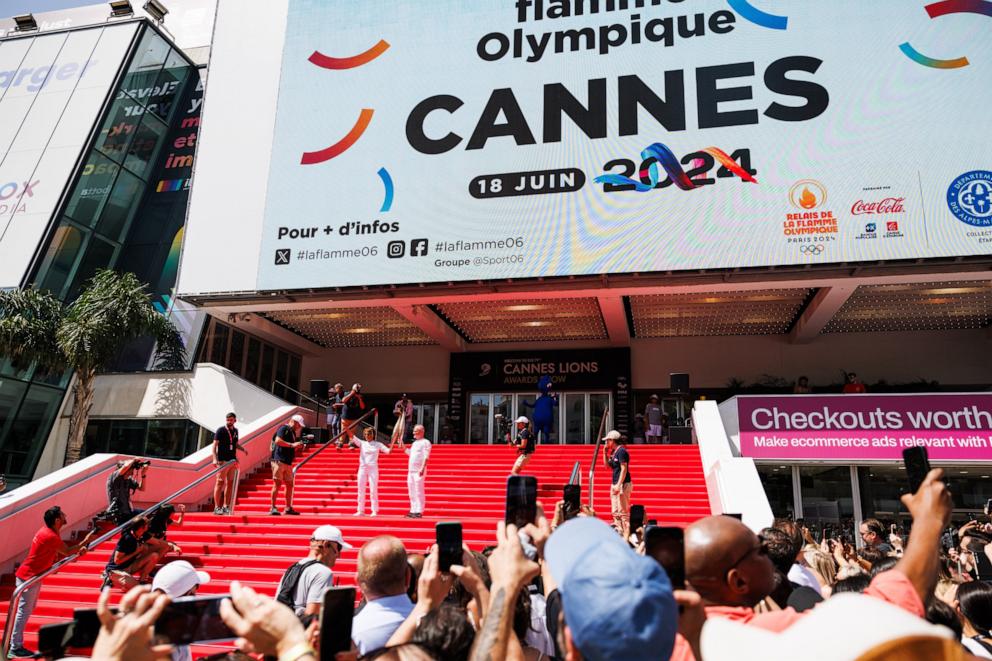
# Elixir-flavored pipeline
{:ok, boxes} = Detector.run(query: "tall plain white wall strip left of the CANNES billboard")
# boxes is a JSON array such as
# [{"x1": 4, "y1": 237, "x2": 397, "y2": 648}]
[{"x1": 176, "y1": 0, "x2": 289, "y2": 296}]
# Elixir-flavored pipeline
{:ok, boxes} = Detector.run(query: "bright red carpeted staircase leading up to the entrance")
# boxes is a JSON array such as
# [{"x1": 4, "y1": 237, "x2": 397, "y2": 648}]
[{"x1": 0, "y1": 445, "x2": 710, "y2": 652}]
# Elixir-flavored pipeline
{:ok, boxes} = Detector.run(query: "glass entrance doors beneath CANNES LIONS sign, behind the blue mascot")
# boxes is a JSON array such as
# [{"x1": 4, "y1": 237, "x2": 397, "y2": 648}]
[{"x1": 468, "y1": 392, "x2": 613, "y2": 445}]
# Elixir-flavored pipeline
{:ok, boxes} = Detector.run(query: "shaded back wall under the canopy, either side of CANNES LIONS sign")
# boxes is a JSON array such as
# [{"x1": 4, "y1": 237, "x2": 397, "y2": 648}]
[{"x1": 303, "y1": 330, "x2": 992, "y2": 392}]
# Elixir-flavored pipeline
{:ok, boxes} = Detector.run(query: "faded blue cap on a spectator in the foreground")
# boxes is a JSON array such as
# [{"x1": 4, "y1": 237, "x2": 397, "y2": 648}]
[{"x1": 544, "y1": 517, "x2": 678, "y2": 661}]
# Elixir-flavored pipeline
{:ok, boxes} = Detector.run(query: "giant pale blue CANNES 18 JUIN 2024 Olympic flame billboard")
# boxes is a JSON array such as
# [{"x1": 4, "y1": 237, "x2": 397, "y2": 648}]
[{"x1": 258, "y1": 0, "x2": 992, "y2": 289}]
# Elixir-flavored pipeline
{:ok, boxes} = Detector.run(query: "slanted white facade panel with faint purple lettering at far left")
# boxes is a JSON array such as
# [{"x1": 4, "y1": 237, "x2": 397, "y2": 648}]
[{"x1": 0, "y1": 23, "x2": 137, "y2": 287}]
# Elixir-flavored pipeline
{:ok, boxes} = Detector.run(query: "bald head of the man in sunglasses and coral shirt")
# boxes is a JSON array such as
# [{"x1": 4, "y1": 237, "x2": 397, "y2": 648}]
[{"x1": 685, "y1": 516, "x2": 775, "y2": 606}]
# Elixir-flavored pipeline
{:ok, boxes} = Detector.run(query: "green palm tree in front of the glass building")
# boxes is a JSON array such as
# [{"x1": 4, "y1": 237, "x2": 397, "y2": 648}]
[{"x1": 0, "y1": 269, "x2": 186, "y2": 465}]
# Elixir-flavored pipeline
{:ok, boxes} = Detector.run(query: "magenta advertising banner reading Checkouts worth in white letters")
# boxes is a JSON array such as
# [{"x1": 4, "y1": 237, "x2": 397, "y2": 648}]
[{"x1": 728, "y1": 393, "x2": 992, "y2": 462}]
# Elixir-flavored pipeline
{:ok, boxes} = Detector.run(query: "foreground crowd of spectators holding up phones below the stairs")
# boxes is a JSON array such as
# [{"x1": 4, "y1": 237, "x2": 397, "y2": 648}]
[{"x1": 15, "y1": 469, "x2": 992, "y2": 661}]
